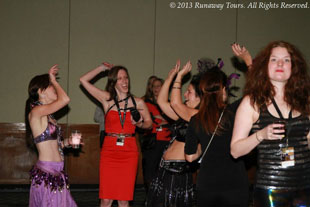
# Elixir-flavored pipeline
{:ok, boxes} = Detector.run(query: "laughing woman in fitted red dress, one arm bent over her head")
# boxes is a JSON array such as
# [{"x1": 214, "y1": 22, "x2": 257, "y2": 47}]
[{"x1": 80, "y1": 63, "x2": 152, "y2": 207}]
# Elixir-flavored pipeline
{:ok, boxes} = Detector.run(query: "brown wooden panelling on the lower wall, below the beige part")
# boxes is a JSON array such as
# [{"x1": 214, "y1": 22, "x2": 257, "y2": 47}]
[{"x1": 0, "y1": 123, "x2": 143, "y2": 184}]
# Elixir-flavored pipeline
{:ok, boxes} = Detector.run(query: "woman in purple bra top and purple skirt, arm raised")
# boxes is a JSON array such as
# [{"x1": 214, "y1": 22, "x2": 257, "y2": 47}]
[{"x1": 26, "y1": 65, "x2": 77, "y2": 207}]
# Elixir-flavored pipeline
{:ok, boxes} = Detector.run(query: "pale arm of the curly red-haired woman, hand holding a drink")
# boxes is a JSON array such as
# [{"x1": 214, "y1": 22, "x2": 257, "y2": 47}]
[{"x1": 230, "y1": 96, "x2": 284, "y2": 158}]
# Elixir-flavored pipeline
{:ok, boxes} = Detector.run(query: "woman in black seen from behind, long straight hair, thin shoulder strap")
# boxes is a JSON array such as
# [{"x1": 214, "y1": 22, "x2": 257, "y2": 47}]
[{"x1": 185, "y1": 67, "x2": 249, "y2": 207}]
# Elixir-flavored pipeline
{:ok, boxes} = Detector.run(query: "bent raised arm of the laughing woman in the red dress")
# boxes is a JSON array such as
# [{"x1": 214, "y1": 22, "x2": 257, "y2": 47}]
[{"x1": 80, "y1": 63, "x2": 112, "y2": 107}]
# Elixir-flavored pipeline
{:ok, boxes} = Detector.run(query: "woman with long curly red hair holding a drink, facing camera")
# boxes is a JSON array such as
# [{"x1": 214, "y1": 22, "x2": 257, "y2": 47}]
[{"x1": 231, "y1": 41, "x2": 310, "y2": 207}]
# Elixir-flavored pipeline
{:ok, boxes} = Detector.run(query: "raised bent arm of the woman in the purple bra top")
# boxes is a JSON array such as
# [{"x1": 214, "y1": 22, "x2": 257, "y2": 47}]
[{"x1": 30, "y1": 64, "x2": 70, "y2": 117}]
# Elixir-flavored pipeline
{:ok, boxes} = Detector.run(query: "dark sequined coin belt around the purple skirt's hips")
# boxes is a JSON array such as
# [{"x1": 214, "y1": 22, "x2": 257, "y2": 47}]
[{"x1": 30, "y1": 166, "x2": 69, "y2": 192}]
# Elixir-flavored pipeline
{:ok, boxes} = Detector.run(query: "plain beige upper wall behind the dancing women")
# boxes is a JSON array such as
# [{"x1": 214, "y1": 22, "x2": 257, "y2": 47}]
[{"x1": 0, "y1": 0, "x2": 310, "y2": 124}]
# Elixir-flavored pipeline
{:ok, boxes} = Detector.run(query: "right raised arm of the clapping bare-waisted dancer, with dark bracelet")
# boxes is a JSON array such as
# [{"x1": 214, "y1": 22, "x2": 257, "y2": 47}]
[{"x1": 170, "y1": 61, "x2": 198, "y2": 121}]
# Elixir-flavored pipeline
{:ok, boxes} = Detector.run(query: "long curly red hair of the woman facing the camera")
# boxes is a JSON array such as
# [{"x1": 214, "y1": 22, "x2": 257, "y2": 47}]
[{"x1": 244, "y1": 41, "x2": 310, "y2": 115}]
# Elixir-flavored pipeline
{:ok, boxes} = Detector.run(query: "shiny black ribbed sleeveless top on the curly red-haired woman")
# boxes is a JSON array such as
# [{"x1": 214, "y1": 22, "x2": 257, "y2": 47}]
[{"x1": 251, "y1": 107, "x2": 310, "y2": 190}]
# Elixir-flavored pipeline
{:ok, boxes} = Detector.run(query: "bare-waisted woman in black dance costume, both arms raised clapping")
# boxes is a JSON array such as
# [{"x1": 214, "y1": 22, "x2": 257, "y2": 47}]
[{"x1": 147, "y1": 61, "x2": 200, "y2": 207}]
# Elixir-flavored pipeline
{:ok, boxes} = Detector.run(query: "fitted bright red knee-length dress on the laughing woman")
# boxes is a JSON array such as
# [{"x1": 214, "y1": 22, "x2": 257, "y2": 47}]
[{"x1": 99, "y1": 110, "x2": 139, "y2": 201}]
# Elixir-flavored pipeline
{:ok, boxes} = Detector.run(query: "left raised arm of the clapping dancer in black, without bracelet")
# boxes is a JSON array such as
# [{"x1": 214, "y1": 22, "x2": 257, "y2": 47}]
[{"x1": 157, "y1": 60, "x2": 180, "y2": 120}]
